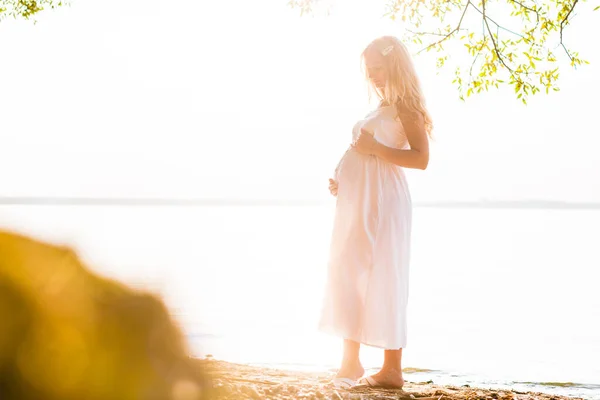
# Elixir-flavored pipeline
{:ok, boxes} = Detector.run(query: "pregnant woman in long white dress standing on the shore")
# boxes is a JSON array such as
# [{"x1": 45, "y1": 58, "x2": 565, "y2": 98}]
[{"x1": 319, "y1": 36, "x2": 432, "y2": 388}]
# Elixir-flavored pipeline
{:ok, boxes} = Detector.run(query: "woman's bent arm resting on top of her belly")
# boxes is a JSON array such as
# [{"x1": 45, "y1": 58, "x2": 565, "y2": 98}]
[{"x1": 353, "y1": 114, "x2": 429, "y2": 169}]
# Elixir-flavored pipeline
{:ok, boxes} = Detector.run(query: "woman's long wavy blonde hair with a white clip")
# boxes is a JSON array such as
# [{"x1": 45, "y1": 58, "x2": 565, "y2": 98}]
[{"x1": 361, "y1": 36, "x2": 433, "y2": 137}]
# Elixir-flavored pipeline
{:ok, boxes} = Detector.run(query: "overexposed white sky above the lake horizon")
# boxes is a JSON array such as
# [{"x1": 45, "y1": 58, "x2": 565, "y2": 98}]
[{"x1": 0, "y1": 0, "x2": 600, "y2": 201}]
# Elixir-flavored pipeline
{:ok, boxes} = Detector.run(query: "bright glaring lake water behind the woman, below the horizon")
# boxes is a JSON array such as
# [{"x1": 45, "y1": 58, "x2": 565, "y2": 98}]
[{"x1": 0, "y1": 203, "x2": 600, "y2": 399}]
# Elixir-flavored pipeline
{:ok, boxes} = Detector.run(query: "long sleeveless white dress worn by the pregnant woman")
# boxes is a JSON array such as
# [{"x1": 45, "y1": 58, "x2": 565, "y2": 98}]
[{"x1": 319, "y1": 106, "x2": 412, "y2": 350}]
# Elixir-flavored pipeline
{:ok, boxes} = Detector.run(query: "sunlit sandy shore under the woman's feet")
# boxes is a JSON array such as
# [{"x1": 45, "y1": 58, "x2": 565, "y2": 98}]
[{"x1": 200, "y1": 359, "x2": 577, "y2": 400}]
